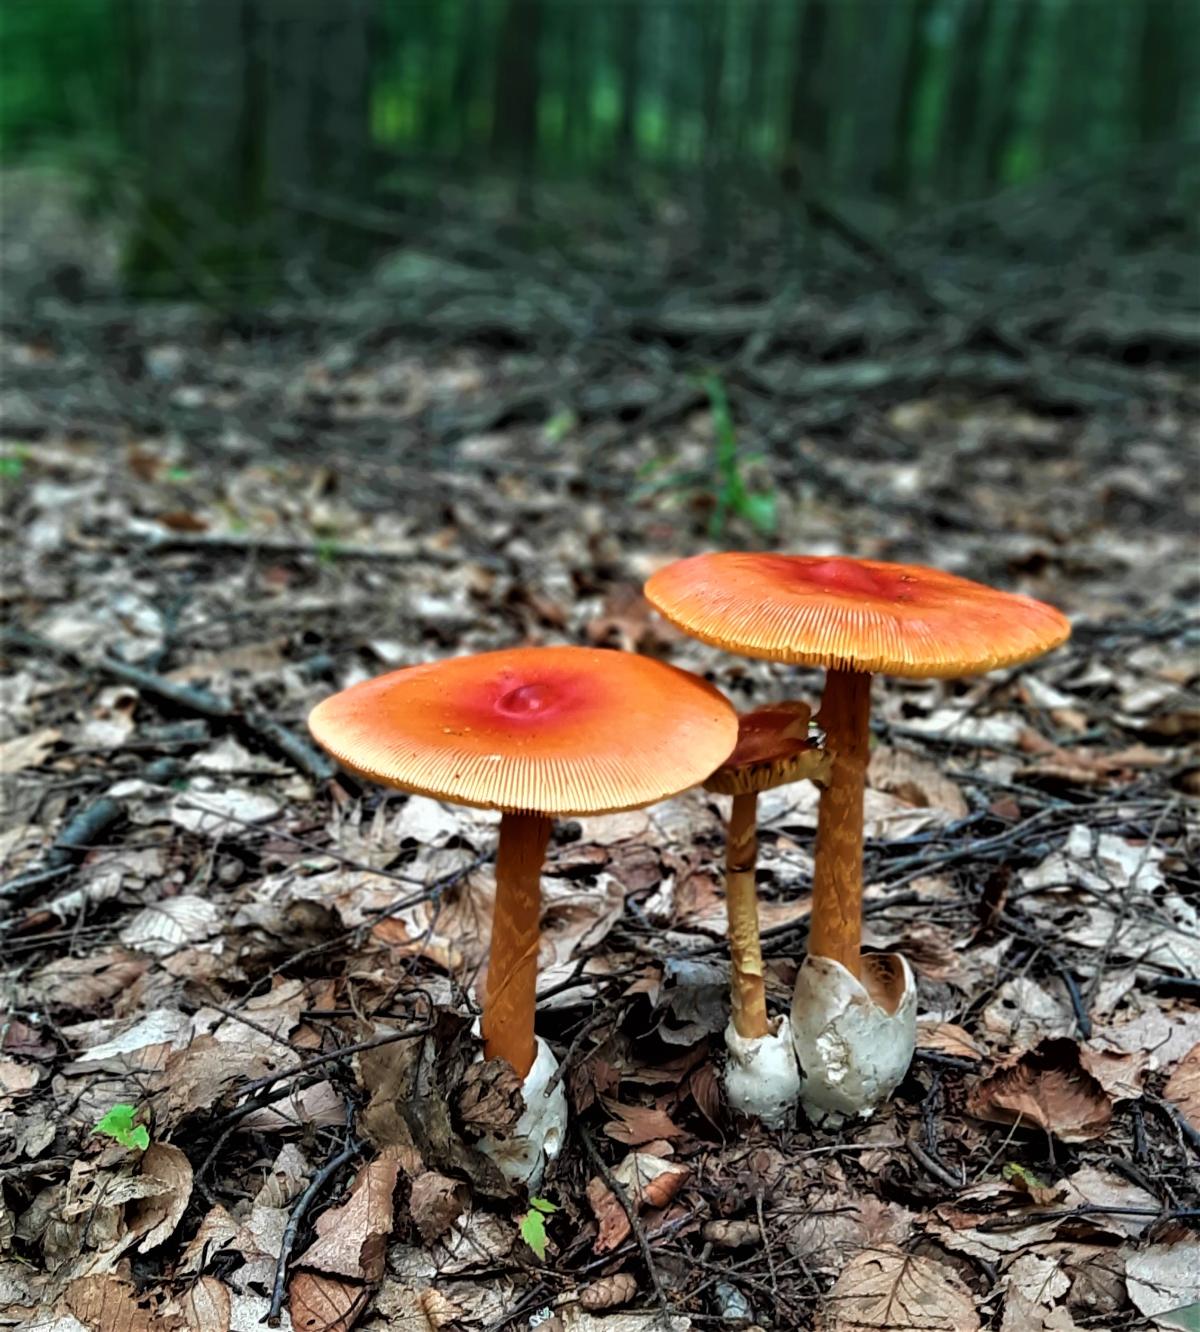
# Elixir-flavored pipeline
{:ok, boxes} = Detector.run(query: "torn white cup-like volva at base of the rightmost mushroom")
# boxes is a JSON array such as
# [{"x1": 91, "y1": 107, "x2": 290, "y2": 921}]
[{"x1": 791, "y1": 954, "x2": 916, "y2": 1124}]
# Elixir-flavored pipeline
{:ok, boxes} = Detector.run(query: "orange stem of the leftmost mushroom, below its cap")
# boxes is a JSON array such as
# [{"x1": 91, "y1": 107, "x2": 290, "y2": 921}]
[{"x1": 479, "y1": 814, "x2": 550, "y2": 1078}]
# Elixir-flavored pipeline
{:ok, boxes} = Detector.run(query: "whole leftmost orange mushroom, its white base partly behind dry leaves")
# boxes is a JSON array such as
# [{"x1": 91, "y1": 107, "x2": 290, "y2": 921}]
[{"x1": 309, "y1": 647, "x2": 738, "y2": 1187}]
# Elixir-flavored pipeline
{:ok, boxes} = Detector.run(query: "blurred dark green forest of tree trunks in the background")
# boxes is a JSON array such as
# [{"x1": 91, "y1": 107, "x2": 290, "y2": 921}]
[{"x1": 0, "y1": 0, "x2": 1200, "y2": 304}]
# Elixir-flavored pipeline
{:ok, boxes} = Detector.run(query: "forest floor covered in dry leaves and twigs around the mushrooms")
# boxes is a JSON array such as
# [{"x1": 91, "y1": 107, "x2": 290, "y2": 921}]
[{"x1": 0, "y1": 193, "x2": 1200, "y2": 1332}]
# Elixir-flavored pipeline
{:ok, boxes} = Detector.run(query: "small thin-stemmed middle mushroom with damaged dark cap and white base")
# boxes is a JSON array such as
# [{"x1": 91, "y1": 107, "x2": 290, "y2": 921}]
[{"x1": 705, "y1": 702, "x2": 828, "y2": 1127}]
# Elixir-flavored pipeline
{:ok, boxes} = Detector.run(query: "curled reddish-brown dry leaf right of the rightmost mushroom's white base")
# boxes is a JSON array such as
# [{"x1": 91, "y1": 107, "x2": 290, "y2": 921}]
[{"x1": 967, "y1": 1036, "x2": 1112, "y2": 1143}]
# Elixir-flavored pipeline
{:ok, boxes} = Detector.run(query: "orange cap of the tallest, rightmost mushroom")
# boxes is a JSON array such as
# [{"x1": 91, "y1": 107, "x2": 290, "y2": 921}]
[{"x1": 646, "y1": 553, "x2": 1071, "y2": 678}]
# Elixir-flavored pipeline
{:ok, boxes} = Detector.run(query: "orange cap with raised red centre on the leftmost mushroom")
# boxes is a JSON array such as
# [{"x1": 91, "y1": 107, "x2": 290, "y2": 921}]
[{"x1": 309, "y1": 647, "x2": 738, "y2": 815}]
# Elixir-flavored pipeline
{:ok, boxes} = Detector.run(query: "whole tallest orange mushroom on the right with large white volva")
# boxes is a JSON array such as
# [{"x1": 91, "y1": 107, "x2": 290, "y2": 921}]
[{"x1": 646, "y1": 553, "x2": 1071, "y2": 1119}]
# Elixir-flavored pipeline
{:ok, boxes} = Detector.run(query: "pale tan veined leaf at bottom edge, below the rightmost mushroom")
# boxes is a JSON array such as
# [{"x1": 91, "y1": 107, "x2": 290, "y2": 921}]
[{"x1": 816, "y1": 1245, "x2": 980, "y2": 1332}]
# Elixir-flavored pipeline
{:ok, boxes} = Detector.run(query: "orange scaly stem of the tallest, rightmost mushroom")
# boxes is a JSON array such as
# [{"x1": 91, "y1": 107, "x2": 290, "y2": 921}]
[{"x1": 808, "y1": 670, "x2": 871, "y2": 976}]
